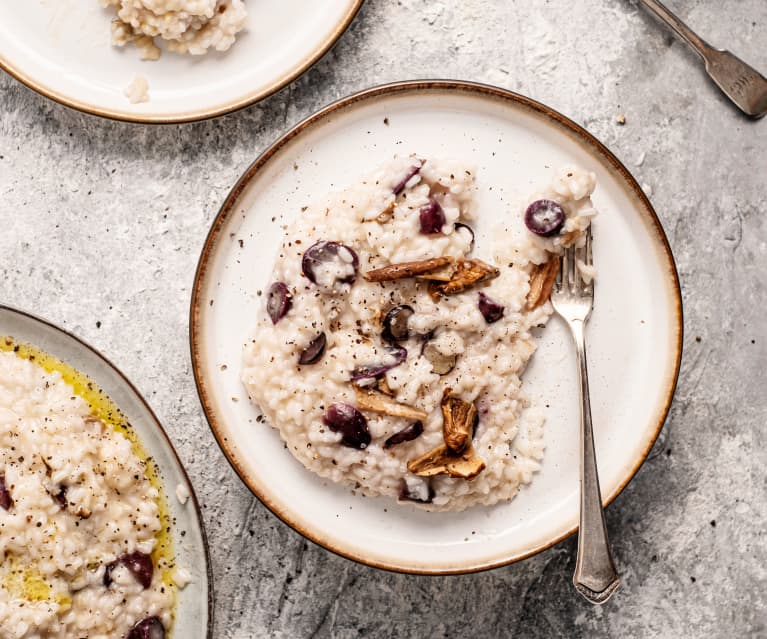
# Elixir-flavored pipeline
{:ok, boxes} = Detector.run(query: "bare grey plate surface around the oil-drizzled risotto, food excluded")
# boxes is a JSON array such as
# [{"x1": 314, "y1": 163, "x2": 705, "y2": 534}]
[{"x1": 0, "y1": 306, "x2": 213, "y2": 639}]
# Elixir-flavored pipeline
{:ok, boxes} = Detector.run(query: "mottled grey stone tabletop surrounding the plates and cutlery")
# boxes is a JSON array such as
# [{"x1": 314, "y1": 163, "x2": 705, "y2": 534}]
[{"x1": 0, "y1": 0, "x2": 767, "y2": 639}]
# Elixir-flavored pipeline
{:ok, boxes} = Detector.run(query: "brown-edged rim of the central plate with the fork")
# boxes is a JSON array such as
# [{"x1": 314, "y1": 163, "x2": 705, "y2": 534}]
[{"x1": 189, "y1": 79, "x2": 684, "y2": 576}]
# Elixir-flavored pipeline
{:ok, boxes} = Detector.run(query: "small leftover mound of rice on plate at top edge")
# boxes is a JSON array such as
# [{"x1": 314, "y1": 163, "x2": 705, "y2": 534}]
[{"x1": 99, "y1": 0, "x2": 248, "y2": 60}]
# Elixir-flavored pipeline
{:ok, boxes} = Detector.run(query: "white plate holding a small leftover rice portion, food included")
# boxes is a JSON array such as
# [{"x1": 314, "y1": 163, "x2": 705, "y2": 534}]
[{"x1": 0, "y1": 0, "x2": 364, "y2": 124}]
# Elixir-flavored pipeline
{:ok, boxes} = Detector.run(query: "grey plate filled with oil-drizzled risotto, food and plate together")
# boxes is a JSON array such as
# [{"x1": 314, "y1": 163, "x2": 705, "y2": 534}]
[{"x1": 0, "y1": 307, "x2": 210, "y2": 639}]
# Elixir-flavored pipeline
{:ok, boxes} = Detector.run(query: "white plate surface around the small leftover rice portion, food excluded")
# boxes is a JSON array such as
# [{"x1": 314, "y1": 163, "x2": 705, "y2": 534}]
[{"x1": 0, "y1": 0, "x2": 363, "y2": 123}]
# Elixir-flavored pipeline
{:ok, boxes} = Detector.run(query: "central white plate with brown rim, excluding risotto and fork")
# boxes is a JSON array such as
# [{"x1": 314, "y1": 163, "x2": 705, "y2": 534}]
[{"x1": 191, "y1": 82, "x2": 682, "y2": 573}]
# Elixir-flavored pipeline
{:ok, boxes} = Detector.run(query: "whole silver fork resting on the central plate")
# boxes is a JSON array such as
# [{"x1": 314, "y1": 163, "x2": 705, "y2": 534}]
[{"x1": 551, "y1": 226, "x2": 620, "y2": 604}]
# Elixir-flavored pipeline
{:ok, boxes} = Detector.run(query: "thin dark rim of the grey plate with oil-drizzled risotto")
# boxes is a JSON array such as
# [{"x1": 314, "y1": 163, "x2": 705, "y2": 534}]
[{"x1": 0, "y1": 304, "x2": 216, "y2": 639}]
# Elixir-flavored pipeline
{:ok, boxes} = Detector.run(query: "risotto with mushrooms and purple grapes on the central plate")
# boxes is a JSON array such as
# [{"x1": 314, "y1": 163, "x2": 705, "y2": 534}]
[{"x1": 242, "y1": 157, "x2": 596, "y2": 510}]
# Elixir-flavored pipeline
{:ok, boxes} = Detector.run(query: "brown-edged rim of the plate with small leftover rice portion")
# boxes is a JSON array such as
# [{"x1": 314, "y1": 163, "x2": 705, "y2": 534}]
[{"x1": 0, "y1": 0, "x2": 365, "y2": 124}]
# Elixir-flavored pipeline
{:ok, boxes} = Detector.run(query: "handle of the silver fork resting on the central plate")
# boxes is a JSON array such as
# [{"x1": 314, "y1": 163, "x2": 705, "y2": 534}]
[{"x1": 570, "y1": 321, "x2": 620, "y2": 603}]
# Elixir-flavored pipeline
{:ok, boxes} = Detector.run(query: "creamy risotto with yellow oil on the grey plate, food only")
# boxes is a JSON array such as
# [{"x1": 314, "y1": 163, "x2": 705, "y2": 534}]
[{"x1": 0, "y1": 352, "x2": 175, "y2": 639}]
